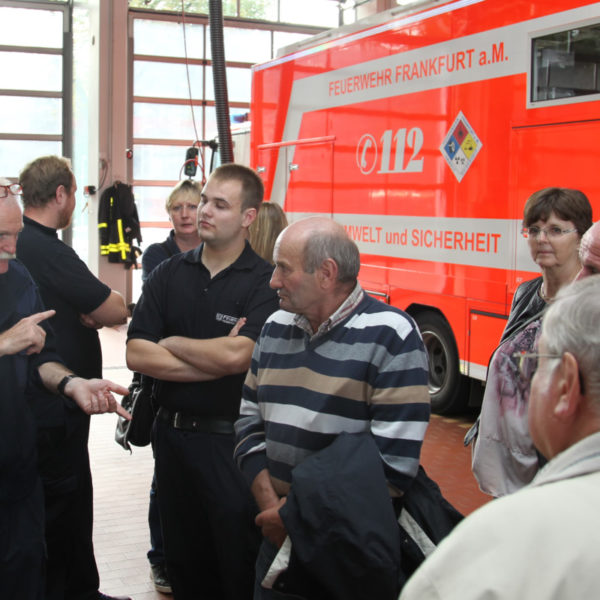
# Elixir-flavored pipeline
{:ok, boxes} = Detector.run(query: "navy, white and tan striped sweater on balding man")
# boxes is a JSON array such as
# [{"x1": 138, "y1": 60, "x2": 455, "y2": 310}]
[{"x1": 235, "y1": 294, "x2": 430, "y2": 495}]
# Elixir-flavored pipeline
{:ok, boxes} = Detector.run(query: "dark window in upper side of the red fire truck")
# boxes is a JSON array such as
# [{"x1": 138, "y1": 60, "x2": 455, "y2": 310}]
[{"x1": 531, "y1": 25, "x2": 600, "y2": 102}]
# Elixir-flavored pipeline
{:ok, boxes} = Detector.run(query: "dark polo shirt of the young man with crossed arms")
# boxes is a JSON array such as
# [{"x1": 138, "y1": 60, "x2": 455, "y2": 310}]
[{"x1": 128, "y1": 242, "x2": 279, "y2": 421}]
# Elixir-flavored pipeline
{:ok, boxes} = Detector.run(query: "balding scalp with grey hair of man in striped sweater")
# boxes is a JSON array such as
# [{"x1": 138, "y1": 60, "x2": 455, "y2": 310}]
[{"x1": 275, "y1": 217, "x2": 360, "y2": 286}]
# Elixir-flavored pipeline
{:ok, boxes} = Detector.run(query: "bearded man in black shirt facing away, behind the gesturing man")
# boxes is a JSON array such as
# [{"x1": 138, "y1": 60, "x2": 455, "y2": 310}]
[{"x1": 17, "y1": 156, "x2": 127, "y2": 600}]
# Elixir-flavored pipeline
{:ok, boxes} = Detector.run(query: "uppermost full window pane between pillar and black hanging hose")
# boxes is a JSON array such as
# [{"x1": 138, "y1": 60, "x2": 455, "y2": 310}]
[{"x1": 133, "y1": 19, "x2": 204, "y2": 59}]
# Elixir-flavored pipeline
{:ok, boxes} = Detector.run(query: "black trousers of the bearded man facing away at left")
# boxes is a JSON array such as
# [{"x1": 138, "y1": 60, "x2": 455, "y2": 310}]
[{"x1": 38, "y1": 410, "x2": 99, "y2": 600}]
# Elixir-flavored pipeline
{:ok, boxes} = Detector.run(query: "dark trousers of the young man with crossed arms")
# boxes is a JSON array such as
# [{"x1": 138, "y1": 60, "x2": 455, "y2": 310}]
[{"x1": 154, "y1": 419, "x2": 261, "y2": 600}]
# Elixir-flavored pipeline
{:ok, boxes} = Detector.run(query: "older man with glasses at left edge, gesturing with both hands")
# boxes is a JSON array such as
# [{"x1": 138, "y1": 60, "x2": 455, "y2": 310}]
[{"x1": 0, "y1": 178, "x2": 127, "y2": 600}]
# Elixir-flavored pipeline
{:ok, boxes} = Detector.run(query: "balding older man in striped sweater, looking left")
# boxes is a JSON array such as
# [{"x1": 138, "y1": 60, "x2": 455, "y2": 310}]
[{"x1": 235, "y1": 217, "x2": 430, "y2": 599}]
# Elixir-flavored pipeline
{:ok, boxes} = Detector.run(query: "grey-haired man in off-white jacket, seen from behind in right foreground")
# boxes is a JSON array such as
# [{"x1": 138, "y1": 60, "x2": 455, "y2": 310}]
[{"x1": 400, "y1": 276, "x2": 600, "y2": 600}]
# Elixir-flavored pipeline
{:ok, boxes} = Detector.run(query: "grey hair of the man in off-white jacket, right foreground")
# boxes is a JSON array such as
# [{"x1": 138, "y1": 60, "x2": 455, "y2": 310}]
[{"x1": 542, "y1": 275, "x2": 600, "y2": 404}]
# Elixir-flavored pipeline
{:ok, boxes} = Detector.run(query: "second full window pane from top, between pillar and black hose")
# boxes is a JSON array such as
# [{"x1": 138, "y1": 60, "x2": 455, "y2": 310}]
[{"x1": 133, "y1": 60, "x2": 202, "y2": 100}]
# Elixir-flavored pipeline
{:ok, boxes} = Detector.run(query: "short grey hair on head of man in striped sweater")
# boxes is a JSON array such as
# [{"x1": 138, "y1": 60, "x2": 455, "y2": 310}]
[{"x1": 302, "y1": 230, "x2": 360, "y2": 284}]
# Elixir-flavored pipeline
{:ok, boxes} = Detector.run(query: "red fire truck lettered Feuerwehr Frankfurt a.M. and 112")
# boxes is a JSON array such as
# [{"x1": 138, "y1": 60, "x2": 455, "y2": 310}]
[{"x1": 250, "y1": 0, "x2": 600, "y2": 413}]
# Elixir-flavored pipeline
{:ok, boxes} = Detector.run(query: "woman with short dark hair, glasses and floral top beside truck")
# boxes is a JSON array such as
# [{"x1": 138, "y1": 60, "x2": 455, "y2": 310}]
[{"x1": 465, "y1": 188, "x2": 592, "y2": 497}]
